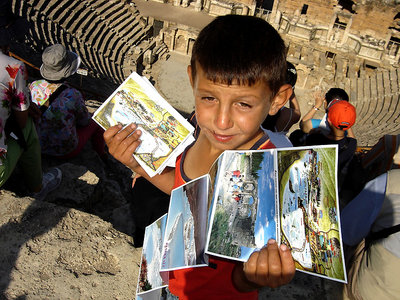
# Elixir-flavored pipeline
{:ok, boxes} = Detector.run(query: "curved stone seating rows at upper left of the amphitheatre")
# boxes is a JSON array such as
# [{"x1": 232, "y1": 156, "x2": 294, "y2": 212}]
[{"x1": 15, "y1": 0, "x2": 150, "y2": 83}]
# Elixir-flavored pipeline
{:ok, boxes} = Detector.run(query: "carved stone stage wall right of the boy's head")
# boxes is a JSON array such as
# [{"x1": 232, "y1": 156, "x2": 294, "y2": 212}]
[{"x1": 272, "y1": 0, "x2": 400, "y2": 66}]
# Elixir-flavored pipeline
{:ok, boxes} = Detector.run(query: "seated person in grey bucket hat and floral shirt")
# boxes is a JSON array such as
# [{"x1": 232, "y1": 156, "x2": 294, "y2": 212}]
[{"x1": 29, "y1": 44, "x2": 104, "y2": 158}]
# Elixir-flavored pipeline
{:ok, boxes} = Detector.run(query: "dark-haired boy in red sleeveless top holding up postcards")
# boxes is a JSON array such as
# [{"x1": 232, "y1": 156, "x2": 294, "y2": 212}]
[{"x1": 104, "y1": 15, "x2": 295, "y2": 299}]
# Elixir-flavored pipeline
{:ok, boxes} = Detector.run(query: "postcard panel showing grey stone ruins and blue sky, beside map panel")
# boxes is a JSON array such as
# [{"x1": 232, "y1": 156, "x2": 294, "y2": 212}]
[{"x1": 207, "y1": 150, "x2": 277, "y2": 261}]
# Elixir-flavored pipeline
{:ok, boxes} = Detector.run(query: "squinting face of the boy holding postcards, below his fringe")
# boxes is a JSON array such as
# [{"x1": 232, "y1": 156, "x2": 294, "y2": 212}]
[{"x1": 188, "y1": 64, "x2": 287, "y2": 151}]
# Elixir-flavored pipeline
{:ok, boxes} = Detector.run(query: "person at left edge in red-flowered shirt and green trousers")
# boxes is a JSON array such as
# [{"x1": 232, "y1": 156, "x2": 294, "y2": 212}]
[{"x1": 0, "y1": 1, "x2": 62, "y2": 200}]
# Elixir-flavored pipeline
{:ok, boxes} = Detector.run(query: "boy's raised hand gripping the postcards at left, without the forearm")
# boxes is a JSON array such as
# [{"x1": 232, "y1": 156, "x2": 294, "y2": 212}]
[{"x1": 103, "y1": 123, "x2": 142, "y2": 171}]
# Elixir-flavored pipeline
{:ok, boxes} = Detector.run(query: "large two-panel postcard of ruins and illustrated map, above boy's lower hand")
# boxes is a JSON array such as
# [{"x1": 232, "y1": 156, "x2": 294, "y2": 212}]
[{"x1": 206, "y1": 146, "x2": 347, "y2": 282}]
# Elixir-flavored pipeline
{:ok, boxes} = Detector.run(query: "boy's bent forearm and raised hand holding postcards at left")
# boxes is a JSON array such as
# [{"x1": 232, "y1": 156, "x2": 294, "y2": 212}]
[{"x1": 104, "y1": 123, "x2": 175, "y2": 194}]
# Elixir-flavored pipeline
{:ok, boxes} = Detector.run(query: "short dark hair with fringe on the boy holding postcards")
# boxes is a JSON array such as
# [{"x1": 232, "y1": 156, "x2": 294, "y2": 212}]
[{"x1": 190, "y1": 15, "x2": 286, "y2": 95}]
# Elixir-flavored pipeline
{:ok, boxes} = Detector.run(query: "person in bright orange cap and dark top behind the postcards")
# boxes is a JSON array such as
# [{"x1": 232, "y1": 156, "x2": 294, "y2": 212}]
[{"x1": 306, "y1": 100, "x2": 357, "y2": 189}]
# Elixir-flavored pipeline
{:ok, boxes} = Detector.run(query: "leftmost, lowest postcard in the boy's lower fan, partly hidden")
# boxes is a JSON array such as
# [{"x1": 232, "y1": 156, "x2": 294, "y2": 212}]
[{"x1": 136, "y1": 214, "x2": 168, "y2": 300}]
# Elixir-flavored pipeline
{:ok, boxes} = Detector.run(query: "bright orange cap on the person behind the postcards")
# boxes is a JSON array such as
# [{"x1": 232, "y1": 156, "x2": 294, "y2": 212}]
[{"x1": 328, "y1": 100, "x2": 356, "y2": 130}]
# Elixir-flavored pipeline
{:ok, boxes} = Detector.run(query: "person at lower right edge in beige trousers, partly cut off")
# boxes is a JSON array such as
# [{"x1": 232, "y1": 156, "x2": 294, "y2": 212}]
[{"x1": 340, "y1": 169, "x2": 400, "y2": 300}]
